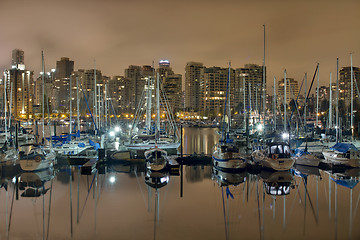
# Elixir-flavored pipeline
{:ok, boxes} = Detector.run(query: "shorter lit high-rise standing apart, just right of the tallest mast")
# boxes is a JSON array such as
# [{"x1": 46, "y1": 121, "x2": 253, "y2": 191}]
[{"x1": 277, "y1": 78, "x2": 299, "y2": 105}]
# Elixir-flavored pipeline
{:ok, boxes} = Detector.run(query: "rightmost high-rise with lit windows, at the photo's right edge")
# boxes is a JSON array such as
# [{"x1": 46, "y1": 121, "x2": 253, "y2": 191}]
[{"x1": 339, "y1": 66, "x2": 360, "y2": 107}]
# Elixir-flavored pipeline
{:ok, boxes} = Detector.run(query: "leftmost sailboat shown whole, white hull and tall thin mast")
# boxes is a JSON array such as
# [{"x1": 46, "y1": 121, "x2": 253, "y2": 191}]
[{"x1": 19, "y1": 51, "x2": 56, "y2": 171}]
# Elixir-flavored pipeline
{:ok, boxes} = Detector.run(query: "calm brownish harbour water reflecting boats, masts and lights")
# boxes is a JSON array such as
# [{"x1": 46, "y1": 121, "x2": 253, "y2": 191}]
[{"x1": 0, "y1": 129, "x2": 360, "y2": 240}]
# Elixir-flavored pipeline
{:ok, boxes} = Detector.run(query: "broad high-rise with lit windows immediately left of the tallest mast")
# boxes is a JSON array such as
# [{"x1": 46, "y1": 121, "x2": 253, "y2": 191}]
[{"x1": 234, "y1": 64, "x2": 266, "y2": 112}]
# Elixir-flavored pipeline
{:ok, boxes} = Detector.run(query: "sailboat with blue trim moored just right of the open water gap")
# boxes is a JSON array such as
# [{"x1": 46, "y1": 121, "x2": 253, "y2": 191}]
[{"x1": 212, "y1": 62, "x2": 247, "y2": 171}]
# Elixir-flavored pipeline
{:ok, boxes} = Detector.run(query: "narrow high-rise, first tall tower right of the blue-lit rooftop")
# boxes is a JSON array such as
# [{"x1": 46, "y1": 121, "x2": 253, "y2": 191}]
[{"x1": 185, "y1": 62, "x2": 205, "y2": 111}]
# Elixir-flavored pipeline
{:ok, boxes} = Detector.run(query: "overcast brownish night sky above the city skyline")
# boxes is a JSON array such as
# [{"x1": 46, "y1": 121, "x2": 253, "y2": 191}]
[{"x1": 0, "y1": 0, "x2": 360, "y2": 91}]
